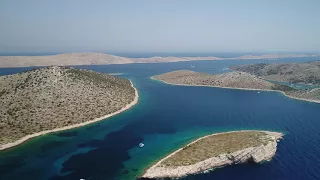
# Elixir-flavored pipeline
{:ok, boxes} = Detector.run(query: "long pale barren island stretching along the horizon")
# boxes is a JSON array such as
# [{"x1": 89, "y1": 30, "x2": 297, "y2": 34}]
[{"x1": 0, "y1": 52, "x2": 320, "y2": 67}]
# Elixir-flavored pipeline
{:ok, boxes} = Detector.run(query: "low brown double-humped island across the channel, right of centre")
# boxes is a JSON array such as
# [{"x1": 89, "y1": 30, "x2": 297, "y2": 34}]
[{"x1": 151, "y1": 70, "x2": 320, "y2": 103}]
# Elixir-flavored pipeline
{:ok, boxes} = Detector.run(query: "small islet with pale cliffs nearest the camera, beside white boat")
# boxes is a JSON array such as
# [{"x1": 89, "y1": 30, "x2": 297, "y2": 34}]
[{"x1": 141, "y1": 130, "x2": 283, "y2": 179}]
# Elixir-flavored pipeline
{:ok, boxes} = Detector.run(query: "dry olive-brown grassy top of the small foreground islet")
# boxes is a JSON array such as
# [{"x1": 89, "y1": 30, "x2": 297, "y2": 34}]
[{"x1": 161, "y1": 131, "x2": 272, "y2": 167}]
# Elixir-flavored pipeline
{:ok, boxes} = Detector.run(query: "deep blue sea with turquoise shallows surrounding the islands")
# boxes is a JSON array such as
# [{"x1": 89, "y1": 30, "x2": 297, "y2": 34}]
[{"x1": 0, "y1": 58, "x2": 320, "y2": 180}]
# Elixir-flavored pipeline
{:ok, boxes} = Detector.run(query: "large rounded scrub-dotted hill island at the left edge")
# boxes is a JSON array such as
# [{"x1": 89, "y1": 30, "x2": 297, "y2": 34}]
[{"x1": 0, "y1": 66, "x2": 138, "y2": 150}]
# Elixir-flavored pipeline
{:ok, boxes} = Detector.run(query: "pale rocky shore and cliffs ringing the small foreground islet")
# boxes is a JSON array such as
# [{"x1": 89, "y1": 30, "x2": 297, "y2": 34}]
[{"x1": 141, "y1": 130, "x2": 283, "y2": 179}]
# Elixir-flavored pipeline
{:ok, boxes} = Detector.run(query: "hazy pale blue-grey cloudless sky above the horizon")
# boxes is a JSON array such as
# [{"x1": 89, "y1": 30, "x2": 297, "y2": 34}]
[{"x1": 0, "y1": 0, "x2": 320, "y2": 53}]
